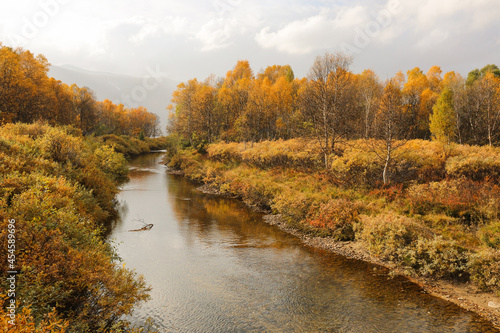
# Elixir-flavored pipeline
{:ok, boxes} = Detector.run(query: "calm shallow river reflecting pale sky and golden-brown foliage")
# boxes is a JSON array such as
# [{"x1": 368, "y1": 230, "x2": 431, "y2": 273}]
[{"x1": 110, "y1": 153, "x2": 498, "y2": 333}]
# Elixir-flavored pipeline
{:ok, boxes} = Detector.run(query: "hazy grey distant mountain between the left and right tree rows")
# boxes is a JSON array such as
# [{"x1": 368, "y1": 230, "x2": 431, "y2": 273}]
[{"x1": 49, "y1": 65, "x2": 178, "y2": 134}]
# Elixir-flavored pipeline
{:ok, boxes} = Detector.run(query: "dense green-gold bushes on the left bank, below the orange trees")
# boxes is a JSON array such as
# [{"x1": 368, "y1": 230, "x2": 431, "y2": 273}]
[{"x1": 0, "y1": 124, "x2": 148, "y2": 332}]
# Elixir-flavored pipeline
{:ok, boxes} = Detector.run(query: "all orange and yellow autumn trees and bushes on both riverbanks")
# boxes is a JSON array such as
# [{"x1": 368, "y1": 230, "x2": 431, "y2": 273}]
[{"x1": 0, "y1": 44, "x2": 500, "y2": 332}]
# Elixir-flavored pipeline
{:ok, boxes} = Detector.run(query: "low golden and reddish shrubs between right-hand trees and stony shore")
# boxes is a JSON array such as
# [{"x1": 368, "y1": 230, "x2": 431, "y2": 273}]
[{"x1": 167, "y1": 139, "x2": 500, "y2": 291}]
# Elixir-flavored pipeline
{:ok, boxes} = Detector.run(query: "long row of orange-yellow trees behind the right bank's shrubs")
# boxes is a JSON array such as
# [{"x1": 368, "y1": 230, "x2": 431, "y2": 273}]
[{"x1": 168, "y1": 53, "x2": 500, "y2": 152}]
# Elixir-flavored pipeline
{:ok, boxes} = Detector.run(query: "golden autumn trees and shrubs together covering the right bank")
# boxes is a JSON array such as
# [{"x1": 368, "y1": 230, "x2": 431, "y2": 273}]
[{"x1": 166, "y1": 53, "x2": 500, "y2": 324}]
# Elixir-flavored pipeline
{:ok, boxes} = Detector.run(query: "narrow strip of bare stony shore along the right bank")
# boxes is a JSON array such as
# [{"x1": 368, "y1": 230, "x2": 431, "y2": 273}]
[{"x1": 190, "y1": 182, "x2": 500, "y2": 331}]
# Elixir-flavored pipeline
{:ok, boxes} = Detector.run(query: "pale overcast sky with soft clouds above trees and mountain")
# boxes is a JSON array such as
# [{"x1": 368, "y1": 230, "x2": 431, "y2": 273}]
[{"x1": 0, "y1": 0, "x2": 500, "y2": 81}]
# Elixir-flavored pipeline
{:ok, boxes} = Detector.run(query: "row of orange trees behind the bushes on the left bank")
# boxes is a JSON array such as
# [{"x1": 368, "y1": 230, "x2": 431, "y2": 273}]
[{"x1": 0, "y1": 43, "x2": 161, "y2": 137}]
